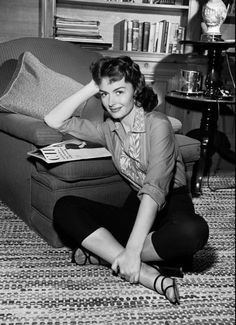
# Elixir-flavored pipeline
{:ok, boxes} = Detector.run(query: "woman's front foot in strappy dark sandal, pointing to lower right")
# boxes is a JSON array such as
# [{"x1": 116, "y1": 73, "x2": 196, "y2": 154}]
[{"x1": 153, "y1": 274, "x2": 180, "y2": 305}]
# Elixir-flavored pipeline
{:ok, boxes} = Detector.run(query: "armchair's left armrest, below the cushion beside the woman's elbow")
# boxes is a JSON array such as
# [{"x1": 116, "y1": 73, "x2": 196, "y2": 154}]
[{"x1": 0, "y1": 113, "x2": 63, "y2": 146}]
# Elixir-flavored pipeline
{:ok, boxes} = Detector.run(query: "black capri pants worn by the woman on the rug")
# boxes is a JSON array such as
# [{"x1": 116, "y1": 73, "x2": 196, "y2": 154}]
[{"x1": 54, "y1": 186, "x2": 209, "y2": 260}]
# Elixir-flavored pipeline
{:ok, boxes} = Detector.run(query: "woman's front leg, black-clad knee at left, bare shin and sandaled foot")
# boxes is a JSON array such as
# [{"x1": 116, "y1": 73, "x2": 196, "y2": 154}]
[{"x1": 54, "y1": 197, "x2": 179, "y2": 303}]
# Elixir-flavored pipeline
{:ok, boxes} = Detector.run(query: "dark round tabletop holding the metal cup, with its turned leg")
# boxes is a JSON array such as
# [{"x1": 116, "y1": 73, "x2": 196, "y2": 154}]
[{"x1": 166, "y1": 91, "x2": 235, "y2": 196}]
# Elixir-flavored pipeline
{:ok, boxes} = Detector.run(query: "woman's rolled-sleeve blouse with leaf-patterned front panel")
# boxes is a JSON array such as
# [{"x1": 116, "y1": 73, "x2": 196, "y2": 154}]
[{"x1": 60, "y1": 107, "x2": 186, "y2": 210}]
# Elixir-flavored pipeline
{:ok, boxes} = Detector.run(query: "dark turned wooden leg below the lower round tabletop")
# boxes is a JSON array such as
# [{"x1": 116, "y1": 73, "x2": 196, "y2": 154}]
[{"x1": 188, "y1": 106, "x2": 218, "y2": 196}]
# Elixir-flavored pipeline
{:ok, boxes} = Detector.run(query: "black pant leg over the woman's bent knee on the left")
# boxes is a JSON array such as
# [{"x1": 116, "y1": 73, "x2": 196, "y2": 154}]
[{"x1": 54, "y1": 196, "x2": 136, "y2": 248}]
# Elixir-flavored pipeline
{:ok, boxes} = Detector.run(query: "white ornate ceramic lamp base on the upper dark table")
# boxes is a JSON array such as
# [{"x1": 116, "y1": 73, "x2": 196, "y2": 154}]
[{"x1": 201, "y1": 0, "x2": 228, "y2": 41}]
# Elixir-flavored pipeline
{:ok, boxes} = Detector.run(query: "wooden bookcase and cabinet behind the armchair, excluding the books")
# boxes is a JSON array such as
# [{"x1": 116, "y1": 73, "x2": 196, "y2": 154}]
[{"x1": 41, "y1": 0, "x2": 204, "y2": 120}]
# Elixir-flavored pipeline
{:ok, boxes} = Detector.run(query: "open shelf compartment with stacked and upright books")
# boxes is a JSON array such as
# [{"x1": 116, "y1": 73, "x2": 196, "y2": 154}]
[{"x1": 44, "y1": 0, "x2": 194, "y2": 56}]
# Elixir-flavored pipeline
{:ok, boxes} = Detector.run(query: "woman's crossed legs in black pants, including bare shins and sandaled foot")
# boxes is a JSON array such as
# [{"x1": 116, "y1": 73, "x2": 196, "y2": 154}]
[{"x1": 54, "y1": 189, "x2": 208, "y2": 302}]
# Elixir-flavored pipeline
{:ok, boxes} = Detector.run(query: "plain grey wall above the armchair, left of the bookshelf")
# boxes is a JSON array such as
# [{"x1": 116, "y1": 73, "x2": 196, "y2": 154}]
[{"x1": 0, "y1": 0, "x2": 40, "y2": 42}]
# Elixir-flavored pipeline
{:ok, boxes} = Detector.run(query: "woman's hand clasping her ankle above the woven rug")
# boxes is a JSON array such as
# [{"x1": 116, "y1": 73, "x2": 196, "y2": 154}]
[{"x1": 111, "y1": 248, "x2": 141, "y2": 283}]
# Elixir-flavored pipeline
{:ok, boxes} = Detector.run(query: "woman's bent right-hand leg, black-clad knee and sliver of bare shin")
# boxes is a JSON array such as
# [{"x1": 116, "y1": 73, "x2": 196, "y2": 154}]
[{"x1": 142, "y1": 190, "x2": 209, "y2": 261}]
